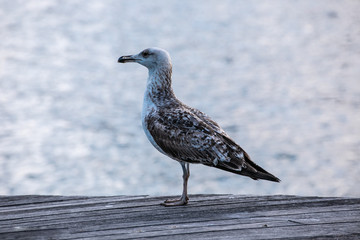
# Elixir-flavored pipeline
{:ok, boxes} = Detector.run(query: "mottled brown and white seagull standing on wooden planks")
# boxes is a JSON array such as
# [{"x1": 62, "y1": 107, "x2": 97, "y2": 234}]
[{"x1": 118, "y1": 47, "x2": 280, "y2": 206}]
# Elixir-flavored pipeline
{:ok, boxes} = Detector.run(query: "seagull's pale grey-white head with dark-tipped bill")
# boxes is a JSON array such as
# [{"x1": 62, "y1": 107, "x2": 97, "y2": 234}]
[{"x1": 118, "y1": 47, "x2": 171, "y2": 70}]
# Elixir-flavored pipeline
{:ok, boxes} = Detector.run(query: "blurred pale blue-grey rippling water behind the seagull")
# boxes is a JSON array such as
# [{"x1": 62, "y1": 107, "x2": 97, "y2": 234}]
[{"x1": 0, "y1": 0, "x2": 360, "y2": 196}]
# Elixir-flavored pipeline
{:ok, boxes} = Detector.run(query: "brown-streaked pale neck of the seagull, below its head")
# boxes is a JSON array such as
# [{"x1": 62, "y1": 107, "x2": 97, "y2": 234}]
[{"x1": 145, "y1": 66, "x2": 176, "y2": 104}]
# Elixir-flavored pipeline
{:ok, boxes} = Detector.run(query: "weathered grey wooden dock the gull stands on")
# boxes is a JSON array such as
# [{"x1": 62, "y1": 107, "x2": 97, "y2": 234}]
[{"x1": 0, "y1": 195, "x2": 360, "y2": 240}]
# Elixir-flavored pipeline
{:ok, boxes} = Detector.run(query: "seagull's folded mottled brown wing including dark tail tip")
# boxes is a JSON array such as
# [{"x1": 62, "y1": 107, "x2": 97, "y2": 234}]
[{"x1": 146, "y1": 107, "x2": 279, "y2": 181}]
